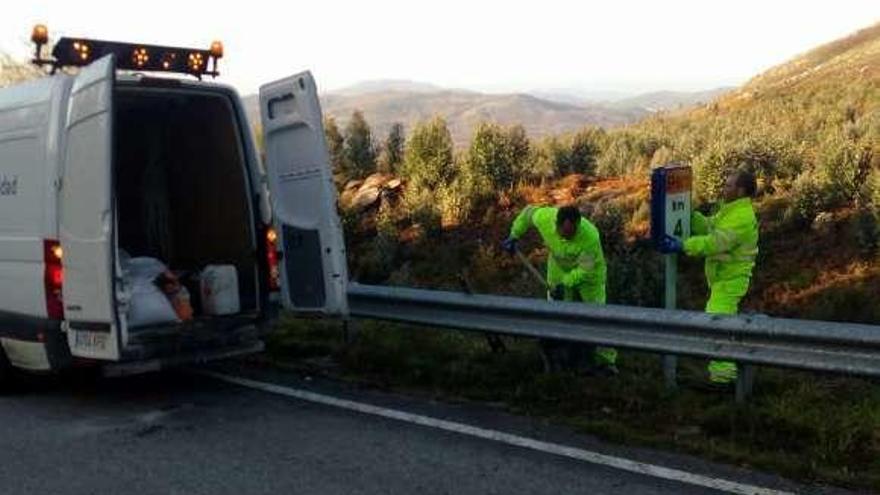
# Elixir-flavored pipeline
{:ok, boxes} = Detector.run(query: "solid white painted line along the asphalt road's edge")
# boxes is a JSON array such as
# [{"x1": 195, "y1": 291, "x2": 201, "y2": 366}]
[{"x1": 199, "y1": 371, "x2": 793, "y2": 495}]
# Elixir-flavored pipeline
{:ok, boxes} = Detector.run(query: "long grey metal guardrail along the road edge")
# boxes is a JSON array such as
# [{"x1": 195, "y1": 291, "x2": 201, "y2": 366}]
[{"x1": 348, "y1": 284, "x2": 880, "y2": 376}]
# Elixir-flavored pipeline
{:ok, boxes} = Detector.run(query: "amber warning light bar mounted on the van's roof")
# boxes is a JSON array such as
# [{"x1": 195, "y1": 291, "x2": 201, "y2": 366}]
[{"x1": 31, "y1": 24, "x2": 223, "y2": 79}]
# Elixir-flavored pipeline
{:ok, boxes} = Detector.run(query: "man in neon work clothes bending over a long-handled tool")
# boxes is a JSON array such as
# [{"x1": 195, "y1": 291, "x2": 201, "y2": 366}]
[{"x1": 502, "y1": 206, "x2": 617, "y2": 375}]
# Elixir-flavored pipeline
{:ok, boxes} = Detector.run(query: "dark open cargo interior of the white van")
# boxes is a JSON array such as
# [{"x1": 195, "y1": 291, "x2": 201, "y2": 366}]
[{"x1": 114, "y1": 86, "x2": 260, "y2": 352}]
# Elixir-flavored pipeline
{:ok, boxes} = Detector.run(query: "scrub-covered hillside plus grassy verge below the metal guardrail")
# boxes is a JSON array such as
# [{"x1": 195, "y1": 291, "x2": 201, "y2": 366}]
[{"x1": 271, "y1": 26, "x2": 880, "y2": 489}]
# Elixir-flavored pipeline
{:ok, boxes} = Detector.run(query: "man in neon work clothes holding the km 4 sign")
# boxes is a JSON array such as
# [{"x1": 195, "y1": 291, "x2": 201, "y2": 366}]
[{"x1": 666, "y1": 171, "x2": 758, "y2": 386}]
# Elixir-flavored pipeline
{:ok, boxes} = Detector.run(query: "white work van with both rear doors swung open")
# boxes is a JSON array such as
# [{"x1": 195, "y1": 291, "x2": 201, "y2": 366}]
[{"x1": 0, "y1": 39, "x2": 348, "y2": 390}]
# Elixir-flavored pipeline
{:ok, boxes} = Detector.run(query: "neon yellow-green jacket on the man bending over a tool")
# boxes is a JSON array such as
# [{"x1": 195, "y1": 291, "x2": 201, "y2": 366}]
[{"x1": 510, "y1": 206, "x2": 607, "y2": 304}]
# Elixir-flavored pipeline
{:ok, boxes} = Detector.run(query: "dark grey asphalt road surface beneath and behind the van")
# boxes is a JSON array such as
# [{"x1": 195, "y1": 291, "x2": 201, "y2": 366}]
[{"x1": 0, "y1": 364, "x2": 852, "y2": 495}]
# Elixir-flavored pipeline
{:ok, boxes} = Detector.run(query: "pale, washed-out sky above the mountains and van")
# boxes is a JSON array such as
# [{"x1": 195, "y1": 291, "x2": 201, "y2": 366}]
[{"x1": 0, "y1": 0, "x2": 880, "y2": 93}]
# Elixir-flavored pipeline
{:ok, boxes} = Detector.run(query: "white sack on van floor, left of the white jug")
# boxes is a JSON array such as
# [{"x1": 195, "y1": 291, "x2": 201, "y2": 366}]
[{"x1": 122, "y1": 257, "x2": 180, "y2": 328}]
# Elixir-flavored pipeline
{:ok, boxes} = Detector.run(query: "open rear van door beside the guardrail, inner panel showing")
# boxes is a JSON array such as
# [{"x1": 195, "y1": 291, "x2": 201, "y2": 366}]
[{"x1": 260, "y1": 72, "x2": 348, "y2": 316}]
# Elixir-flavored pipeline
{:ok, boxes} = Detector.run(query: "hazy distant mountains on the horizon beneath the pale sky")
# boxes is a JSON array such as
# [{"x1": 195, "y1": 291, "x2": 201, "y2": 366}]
[{"x1": 245, "y1": 80, "x2": 724, "y2": 145}]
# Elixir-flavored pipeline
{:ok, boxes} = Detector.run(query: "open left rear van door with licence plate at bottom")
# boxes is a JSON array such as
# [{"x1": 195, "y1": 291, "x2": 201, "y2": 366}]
[{"x1": 58, "y1": 55, "x2": 120, "y2": 360}]
